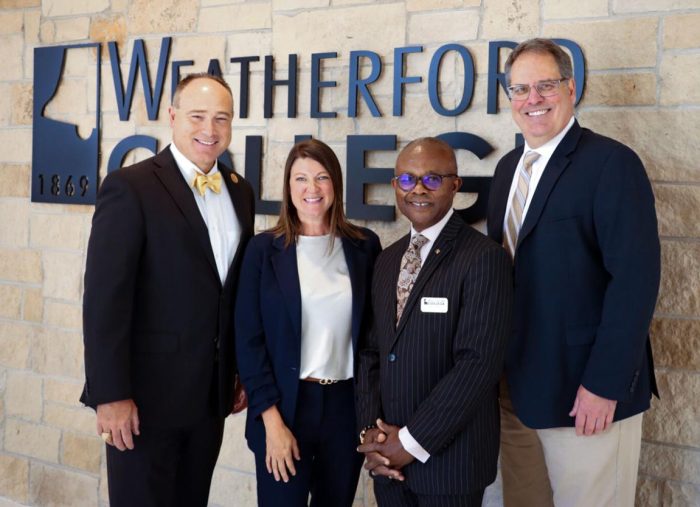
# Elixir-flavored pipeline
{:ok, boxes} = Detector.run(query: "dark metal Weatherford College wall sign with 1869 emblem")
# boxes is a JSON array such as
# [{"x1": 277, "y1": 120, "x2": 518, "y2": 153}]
[{"x1": 32, "y1": 33, "x2": 585, "y2": 223}]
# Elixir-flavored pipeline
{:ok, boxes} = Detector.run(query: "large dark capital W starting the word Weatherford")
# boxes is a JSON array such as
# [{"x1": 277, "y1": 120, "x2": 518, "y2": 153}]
[{"x1": 107, "y1": 37, "x2": 172, "y2": 121}]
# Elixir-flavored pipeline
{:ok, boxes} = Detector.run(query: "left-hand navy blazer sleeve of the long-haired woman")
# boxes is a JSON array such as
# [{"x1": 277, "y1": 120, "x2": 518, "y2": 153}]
[{"x1": 234, "y1": 237, "x2": 281, "y2": 417}]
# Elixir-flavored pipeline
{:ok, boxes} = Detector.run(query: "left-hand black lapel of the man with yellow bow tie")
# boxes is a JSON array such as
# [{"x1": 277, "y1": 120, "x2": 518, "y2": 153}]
[{"x1": 153, "y1": 147, "x2": 221, "y2": 283}]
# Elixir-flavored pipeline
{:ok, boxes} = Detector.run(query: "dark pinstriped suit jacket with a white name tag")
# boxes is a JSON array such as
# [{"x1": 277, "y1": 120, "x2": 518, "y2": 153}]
[{"x1": 357, "y1": 214, "x2": 512, "y2": 495}]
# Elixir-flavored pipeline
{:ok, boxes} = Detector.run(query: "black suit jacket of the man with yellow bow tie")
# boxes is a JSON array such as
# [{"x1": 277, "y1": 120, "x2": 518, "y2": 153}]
[{"x1": 81, "y1": 147, "x2": 254, "y2": 427}]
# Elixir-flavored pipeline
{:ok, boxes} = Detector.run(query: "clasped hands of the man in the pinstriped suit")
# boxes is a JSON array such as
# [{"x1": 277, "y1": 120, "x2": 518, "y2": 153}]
[{"x1": 357, "y1": 419, "x2": 415, "y2": 481}]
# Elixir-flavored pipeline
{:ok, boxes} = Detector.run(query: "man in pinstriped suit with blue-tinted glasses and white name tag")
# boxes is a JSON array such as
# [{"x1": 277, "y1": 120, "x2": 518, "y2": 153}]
[{"x1": 357, "y1": 138, "x2": 512, "y2": 507}]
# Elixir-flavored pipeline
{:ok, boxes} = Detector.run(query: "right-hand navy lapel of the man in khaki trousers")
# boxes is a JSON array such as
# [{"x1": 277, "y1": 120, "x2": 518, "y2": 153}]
[{"x1": 515, "y1": 120, "x2": 581, "y2": 250}]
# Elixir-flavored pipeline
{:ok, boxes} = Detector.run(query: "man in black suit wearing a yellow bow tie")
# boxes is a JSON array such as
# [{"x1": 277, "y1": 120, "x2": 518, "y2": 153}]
[{"x1": 81, "y1": 74, "x2": 254, "y2": 507}]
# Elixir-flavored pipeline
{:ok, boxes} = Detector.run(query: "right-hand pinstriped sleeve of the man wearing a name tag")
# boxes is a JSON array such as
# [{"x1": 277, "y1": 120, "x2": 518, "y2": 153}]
[{"x1": 406, "y1": 245, "x2": 513, "y2": 455}]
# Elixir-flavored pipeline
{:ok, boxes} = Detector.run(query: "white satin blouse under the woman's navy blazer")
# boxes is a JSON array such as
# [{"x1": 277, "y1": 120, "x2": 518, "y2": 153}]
[{"x1": 296, "y1": 235, "x2": 353, "y2": 380}]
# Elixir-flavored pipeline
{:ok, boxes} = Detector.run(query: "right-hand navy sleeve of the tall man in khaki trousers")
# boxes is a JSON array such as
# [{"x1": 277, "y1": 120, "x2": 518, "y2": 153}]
[{"x1": 581, "y1": 145, "x2": 661, "y2": 402}]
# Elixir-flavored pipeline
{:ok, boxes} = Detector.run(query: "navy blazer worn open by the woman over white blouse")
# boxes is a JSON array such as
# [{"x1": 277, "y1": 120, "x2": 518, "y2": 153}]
[{"x1": 235, "y1": 228, "x2": 381, "y2": 452}]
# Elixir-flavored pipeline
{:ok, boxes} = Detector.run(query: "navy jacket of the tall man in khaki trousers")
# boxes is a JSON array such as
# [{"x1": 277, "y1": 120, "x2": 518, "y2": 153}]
[{"x1": 488, "y1": 122, "x2": 660, "y2": 428}]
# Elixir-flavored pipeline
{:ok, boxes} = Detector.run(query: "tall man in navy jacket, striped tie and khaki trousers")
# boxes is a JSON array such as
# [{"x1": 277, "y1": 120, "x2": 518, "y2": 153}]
[{"x1": 488, "y1": 39, "x2": 660, "y2": 507}]
